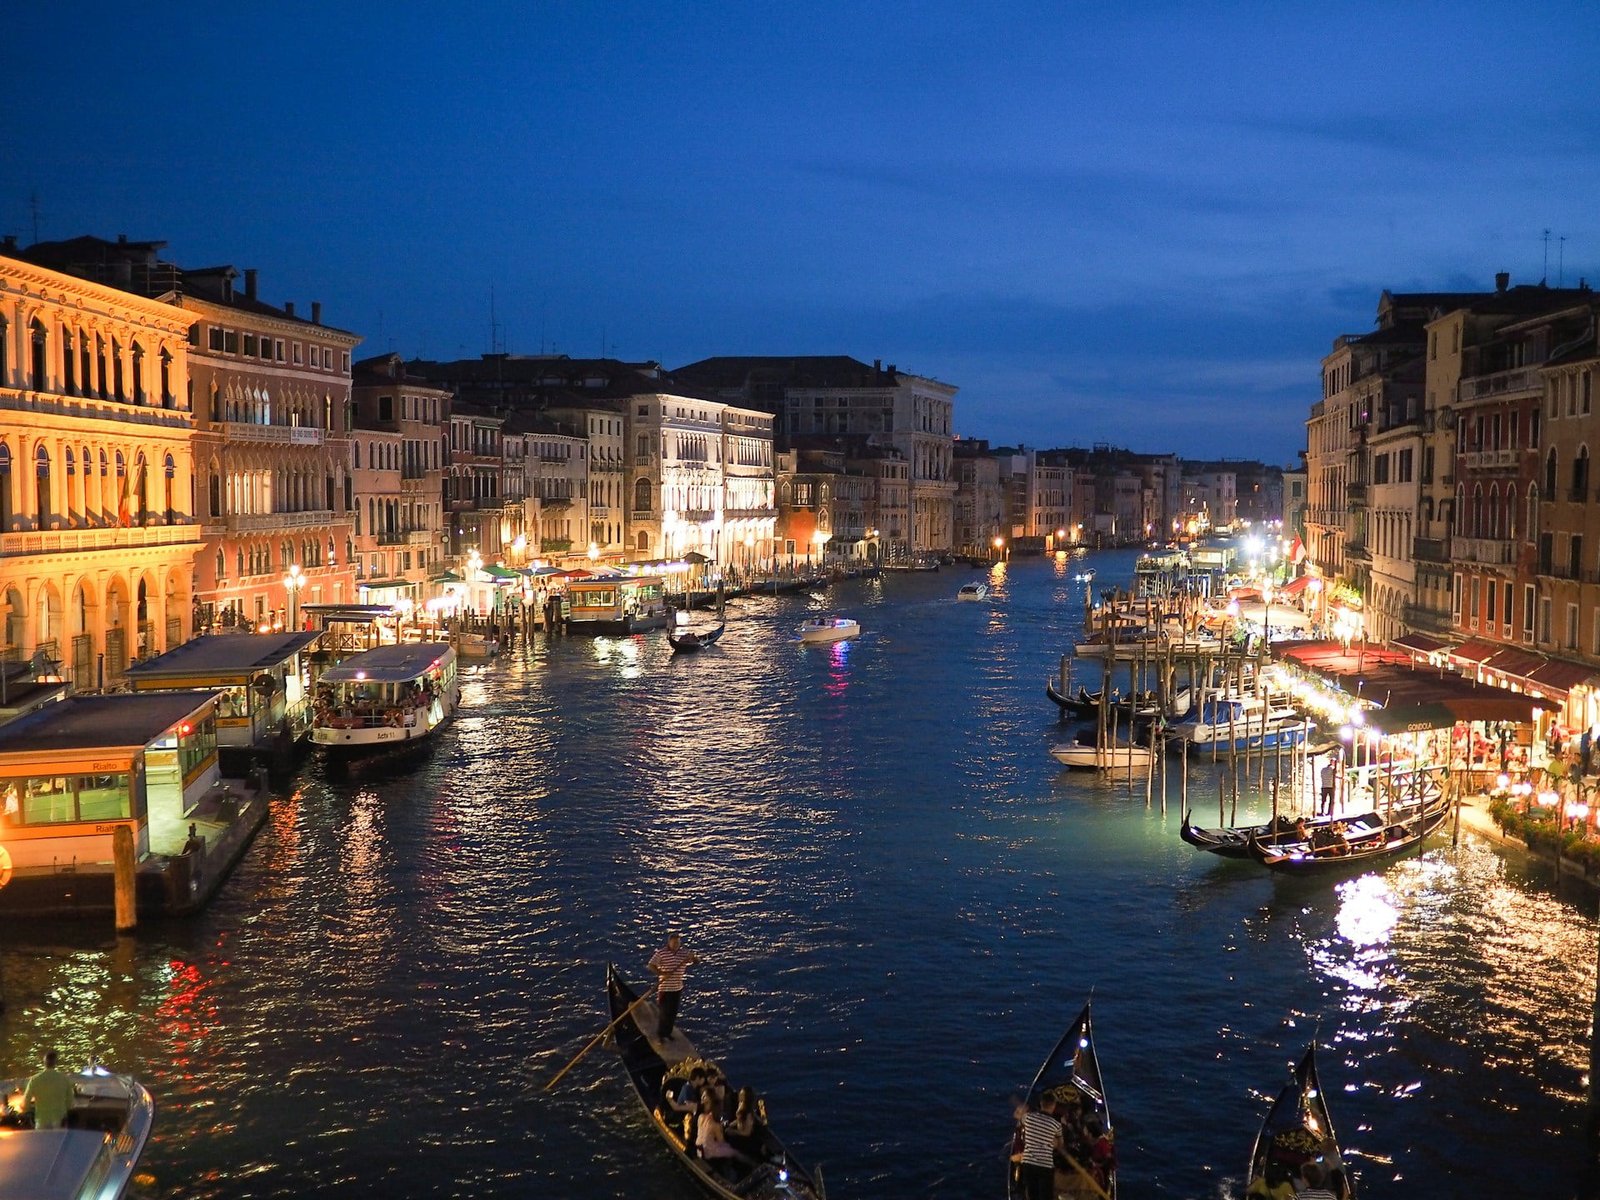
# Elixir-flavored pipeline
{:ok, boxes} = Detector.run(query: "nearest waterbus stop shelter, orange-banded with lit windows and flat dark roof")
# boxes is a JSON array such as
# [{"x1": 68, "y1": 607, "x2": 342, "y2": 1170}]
[{"x1": 0, "y1": 691, "x2": 218, "y2": 874}]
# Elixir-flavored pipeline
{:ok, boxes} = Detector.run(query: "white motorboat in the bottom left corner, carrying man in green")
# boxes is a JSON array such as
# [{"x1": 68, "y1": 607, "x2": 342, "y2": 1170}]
[{"x1": 0, "y1": 1062, "x2": 155, "y2": 1200}]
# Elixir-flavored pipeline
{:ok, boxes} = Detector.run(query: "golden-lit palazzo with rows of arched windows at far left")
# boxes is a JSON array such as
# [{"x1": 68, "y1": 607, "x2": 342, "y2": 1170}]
[{"x1": 0, "y1": 242, "x2": 200, "y2": 690}]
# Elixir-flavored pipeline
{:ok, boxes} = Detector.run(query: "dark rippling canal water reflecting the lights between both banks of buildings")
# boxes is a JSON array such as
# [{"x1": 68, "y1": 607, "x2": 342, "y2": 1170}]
[{"x1": 0, "y1": 554, "x2": 1595, "y2": 1200}]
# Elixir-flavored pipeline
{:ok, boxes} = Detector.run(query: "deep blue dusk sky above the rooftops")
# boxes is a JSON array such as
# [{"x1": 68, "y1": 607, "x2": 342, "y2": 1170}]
[{"x1": 0, "y1": 0, "x2": 1600, "y2": 462}]
